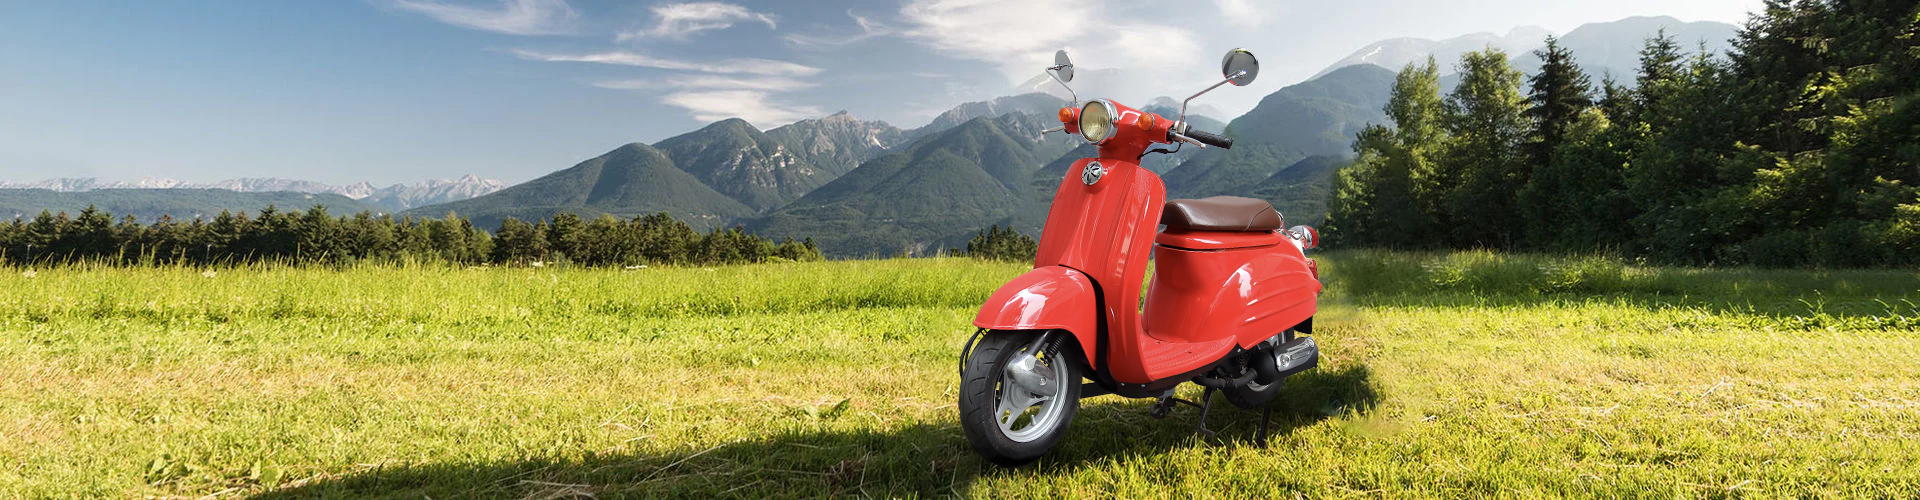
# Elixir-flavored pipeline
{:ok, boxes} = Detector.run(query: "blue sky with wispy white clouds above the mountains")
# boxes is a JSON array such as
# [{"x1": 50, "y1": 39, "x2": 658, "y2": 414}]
[{"x1": 0, "y1": 0, "x2": 1761, "y2": 183}]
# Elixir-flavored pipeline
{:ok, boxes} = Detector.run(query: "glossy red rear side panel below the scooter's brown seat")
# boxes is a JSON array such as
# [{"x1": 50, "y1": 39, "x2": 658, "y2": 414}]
[{"x1": 1146, "y1": 244, "x2": 1321, "y2": 348}]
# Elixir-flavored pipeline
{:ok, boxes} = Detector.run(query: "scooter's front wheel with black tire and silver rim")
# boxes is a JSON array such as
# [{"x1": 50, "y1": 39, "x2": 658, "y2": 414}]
[{"x1": 960, "y1": 331, "x2": 1083, "y2": 467}]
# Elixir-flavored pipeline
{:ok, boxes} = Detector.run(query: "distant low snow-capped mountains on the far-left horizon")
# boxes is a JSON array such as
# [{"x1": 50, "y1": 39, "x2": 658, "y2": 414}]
[{"x1": 0, "y1": 175, "x2": 507, "y2": 212}]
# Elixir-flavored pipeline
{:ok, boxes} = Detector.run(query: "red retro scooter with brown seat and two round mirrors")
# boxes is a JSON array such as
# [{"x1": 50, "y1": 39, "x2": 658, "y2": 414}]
[{"x1": 960, "y1": 48, "x2": 1321, "y2": 467}]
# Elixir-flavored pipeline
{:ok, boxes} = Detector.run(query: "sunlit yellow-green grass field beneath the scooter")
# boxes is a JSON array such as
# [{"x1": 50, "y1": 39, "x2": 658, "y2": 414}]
[{"x1": 0, "y1": 252, "x2": 1920, "y2": 498}]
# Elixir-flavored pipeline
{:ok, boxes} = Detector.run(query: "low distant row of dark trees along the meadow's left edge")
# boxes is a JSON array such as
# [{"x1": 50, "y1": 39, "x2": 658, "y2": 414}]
[{"x1": 0, "y1": 206, "x2": 820, "y2": 265}]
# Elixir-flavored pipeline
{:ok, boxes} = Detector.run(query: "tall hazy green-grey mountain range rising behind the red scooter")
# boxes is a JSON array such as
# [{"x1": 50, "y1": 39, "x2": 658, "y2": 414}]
[{"x1": 0, "y1": 17, "x2": 1736, "y2": 256}]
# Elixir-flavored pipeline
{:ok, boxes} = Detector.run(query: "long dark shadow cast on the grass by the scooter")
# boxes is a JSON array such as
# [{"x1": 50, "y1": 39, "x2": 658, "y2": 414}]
[{"x1": 257, "y1": 365, "x2": 1379, "y2": 498}]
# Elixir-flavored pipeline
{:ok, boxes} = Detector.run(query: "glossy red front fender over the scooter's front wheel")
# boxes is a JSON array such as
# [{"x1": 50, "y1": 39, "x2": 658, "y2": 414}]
[{"x1": 973, "y1": 265, "x2": 1100, "y2": 360}]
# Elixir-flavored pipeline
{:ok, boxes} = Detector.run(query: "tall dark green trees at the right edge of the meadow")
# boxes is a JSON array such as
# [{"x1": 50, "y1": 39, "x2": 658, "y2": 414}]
[{"x1": 1327, "y1": 0, "x2": 1920, "y2": 267}]
